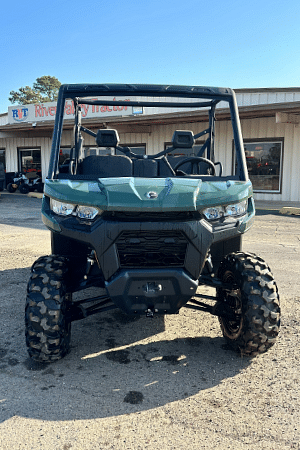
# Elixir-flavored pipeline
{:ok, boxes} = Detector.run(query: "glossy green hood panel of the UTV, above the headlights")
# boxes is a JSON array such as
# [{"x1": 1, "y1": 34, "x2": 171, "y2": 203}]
[{"x1": 45, "y1": 177, "x2": 252, "y2": 211}]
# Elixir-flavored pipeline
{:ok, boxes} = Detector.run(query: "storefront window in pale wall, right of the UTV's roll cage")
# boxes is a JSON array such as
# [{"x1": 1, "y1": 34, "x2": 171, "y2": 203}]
[{"x1": 244, "y1": 139, "x2": 283, "y2": 192}]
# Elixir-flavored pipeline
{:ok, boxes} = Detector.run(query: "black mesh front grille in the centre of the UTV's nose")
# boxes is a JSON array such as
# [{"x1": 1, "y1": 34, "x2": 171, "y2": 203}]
[{"x1": 116, "y1": 231, "x2": 188, "y2": 268}]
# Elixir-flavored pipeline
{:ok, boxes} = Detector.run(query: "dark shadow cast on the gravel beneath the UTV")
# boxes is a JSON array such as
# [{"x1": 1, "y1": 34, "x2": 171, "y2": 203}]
[{"x1": 0, "y1": 268, "x2": 251, "y2": 422}]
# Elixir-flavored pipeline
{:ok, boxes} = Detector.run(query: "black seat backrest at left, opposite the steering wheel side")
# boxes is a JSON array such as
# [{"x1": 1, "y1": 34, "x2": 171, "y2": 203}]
[{"x1": 80, "y1": 155, "x2": 132, "y2": 178}]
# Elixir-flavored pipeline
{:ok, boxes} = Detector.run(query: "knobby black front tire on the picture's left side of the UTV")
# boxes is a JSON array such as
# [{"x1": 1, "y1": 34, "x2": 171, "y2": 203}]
[{"x1": 25, "y1": 255, "x2": 71, "y2": 362}]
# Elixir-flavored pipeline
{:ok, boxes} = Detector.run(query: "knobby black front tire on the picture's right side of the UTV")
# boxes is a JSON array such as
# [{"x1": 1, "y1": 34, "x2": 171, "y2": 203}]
[{"x1": 217, "y1": 252, "x2": 280, "y2": 356}]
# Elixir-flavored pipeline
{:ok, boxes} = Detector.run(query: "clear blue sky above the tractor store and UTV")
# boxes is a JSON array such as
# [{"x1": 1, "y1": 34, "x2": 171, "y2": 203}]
[{"x1": 0, "y1": 0, "x2": 300, "y2": 113}]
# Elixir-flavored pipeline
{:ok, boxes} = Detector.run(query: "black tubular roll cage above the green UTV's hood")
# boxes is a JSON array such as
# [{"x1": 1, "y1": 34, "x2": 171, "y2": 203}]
[{"x1": 48, "y1": 84, "x2": 248, "y2": 181}]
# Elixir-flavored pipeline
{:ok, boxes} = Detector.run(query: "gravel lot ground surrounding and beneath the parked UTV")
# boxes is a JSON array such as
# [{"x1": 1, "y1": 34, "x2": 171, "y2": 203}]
[{"x1": 0, "y1": 193, "x2": 300, "y2": 450}]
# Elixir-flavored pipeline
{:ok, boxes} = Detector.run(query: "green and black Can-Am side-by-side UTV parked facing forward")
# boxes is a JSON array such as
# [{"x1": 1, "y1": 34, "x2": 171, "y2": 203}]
[{"x1": 25, "y1": 84, "x2": 280, "y2": 362}]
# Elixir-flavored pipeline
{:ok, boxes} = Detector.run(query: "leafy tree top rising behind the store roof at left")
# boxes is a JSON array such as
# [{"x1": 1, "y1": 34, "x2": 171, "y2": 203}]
[{"x1": 8, "y1": 75, "x2": 61, "y2": 105}]
